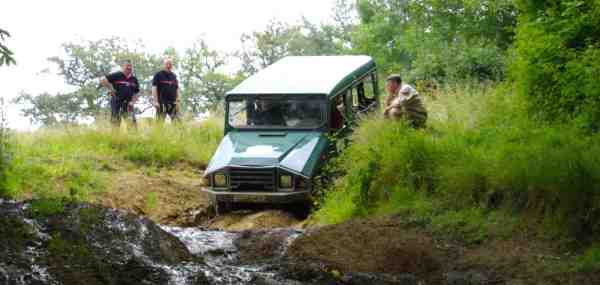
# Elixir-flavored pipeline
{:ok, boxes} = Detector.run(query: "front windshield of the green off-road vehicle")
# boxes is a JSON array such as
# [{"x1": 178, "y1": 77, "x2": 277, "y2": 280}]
[{"x1": 227, "y1": 96, "x2": 326, "y2": 128}]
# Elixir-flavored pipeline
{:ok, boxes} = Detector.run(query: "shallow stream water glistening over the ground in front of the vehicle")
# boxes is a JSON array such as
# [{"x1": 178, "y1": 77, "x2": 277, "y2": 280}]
[{"x1": 161, "y1": 226, "x2": 302, "y2": 284}]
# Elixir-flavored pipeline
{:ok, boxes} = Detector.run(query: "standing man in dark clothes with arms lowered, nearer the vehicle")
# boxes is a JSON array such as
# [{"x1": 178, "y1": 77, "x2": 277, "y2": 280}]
[{"x1": 152, "y1": 58, "x2": 180, "y2": 121}]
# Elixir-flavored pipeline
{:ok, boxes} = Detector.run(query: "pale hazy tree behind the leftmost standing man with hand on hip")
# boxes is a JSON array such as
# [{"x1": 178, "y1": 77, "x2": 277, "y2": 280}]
[{"x1": 15, "y1": 37, "x2": 162, "y2": 125}]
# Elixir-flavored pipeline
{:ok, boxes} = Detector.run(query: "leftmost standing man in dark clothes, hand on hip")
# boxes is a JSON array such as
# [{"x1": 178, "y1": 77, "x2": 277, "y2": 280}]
[{"x1": 100, "y1": 60, "x2": 140, "y2": 125}]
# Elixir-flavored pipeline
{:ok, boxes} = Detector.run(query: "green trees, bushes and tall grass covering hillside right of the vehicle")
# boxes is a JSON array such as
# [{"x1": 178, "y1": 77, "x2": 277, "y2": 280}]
[{"x1": 308, "y1": 0, "x2": 600, "y2": 270}]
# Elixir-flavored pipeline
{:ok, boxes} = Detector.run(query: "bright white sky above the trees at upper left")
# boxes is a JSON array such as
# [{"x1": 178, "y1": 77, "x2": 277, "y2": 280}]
[{"x1": 0, "y1": 0, "x2": 334, "y2": 129}]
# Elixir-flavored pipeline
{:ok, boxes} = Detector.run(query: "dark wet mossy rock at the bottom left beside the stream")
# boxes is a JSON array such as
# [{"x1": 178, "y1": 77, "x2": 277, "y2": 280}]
[{"x1": 0, "y1": 201, "x2": 205, "y2": 285}]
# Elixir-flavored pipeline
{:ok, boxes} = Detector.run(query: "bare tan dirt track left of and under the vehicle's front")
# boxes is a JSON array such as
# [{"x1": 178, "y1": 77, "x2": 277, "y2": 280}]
[{"x1": 97, "y1": 165, "x2": 310, "y2": 231}]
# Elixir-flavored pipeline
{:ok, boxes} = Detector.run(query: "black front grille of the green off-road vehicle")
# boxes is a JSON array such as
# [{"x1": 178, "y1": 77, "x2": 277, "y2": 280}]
[{"x1": 229, "y1": 168, "x2": 275, "y2": 192}]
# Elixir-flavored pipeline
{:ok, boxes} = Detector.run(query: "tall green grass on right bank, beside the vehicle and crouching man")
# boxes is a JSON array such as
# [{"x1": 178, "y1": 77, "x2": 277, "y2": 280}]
[{"x1": 316, "y1": 86, "x2": 600, "y2": 244}]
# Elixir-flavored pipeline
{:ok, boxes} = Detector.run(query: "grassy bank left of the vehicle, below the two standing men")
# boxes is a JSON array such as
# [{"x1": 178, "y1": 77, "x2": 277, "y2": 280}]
[{"x1": 0, "y1": 119, "x2": 223, "y2": 201}]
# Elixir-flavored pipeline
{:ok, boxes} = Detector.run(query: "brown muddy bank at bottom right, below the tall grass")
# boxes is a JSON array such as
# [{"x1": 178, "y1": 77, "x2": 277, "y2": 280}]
[{"x1": 287, "y1": 217, "x2": 600, "y2": 285}]
